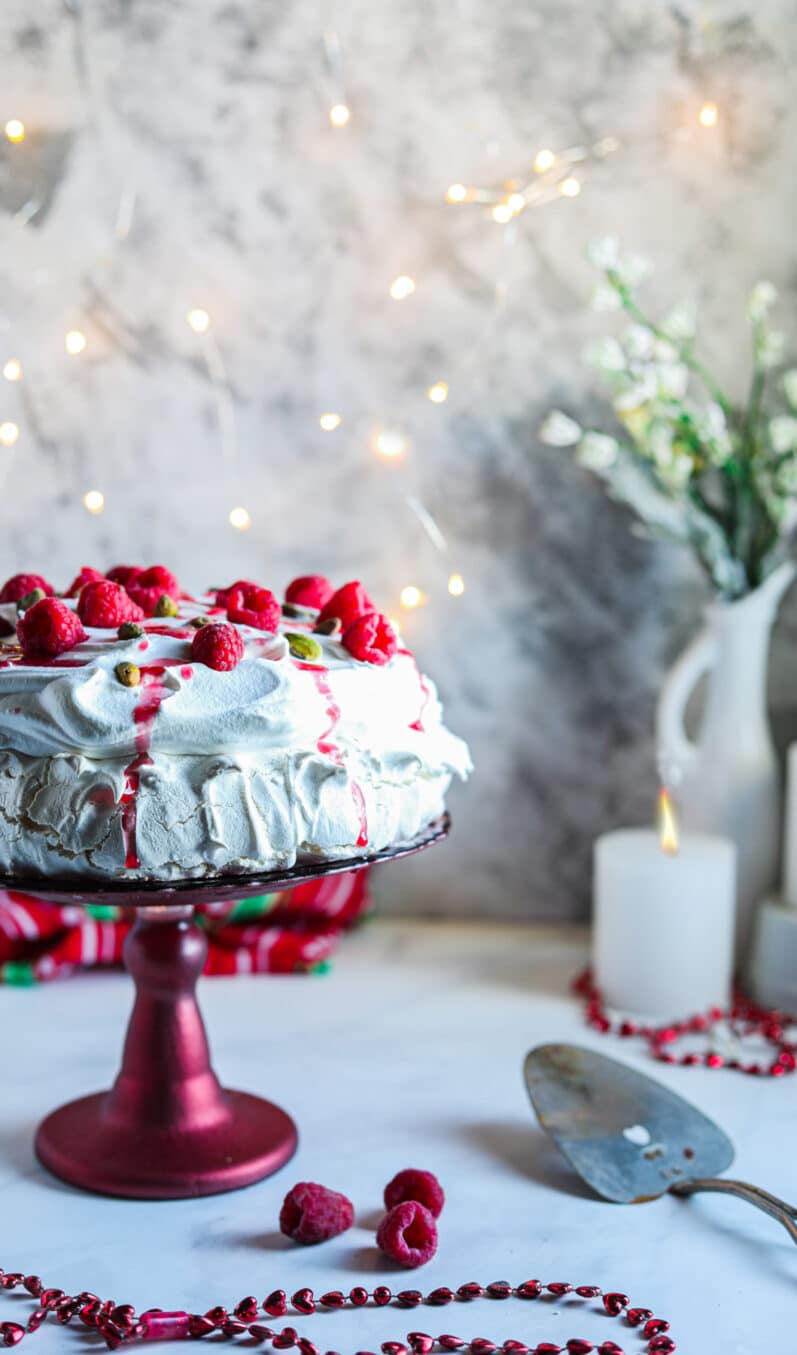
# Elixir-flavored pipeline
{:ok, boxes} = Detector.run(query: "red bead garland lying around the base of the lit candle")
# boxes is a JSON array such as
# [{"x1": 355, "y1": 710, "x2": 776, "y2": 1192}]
[{"x1": 573, "y1": 969, "x2": 797, "y2": 1077}]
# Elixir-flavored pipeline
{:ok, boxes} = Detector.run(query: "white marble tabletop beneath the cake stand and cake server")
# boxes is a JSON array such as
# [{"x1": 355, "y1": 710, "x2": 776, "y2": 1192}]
[{"x1": 0, "y1": 921, "x2": 797, "y2": 1355}]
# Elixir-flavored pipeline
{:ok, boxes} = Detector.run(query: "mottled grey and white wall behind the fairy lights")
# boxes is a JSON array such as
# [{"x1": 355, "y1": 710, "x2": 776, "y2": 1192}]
[{"x1": 0, "y1": 0, "x2": 797, "y2": 916}]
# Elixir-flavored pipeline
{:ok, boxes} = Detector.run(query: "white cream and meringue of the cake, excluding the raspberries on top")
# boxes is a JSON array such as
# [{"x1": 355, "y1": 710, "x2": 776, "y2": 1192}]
[{"x1": 0, "y1": 596, "x2": 470, "y2": 878}]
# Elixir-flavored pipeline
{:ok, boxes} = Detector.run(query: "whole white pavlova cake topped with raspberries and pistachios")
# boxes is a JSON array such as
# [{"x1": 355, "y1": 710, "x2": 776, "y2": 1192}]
[{"x1": 0, "y1": 565, "x2": 470, "y2": 879}]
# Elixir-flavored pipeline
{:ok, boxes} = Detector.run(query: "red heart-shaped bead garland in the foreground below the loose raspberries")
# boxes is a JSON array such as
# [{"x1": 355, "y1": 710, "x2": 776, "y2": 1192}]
[{"x1": 0, "y1": 1270, "x2": 676, "y2": 1355}]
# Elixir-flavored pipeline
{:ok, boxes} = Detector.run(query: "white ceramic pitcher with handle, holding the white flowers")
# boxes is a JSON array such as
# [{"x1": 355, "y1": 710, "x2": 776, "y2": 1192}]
[{"x1": 656, "y1": 561, "x2": 794, "y2": 958}]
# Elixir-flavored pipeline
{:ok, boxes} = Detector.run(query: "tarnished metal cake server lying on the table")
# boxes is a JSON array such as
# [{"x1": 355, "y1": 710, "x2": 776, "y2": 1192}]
[{"x1": 523, "y1": 1045, "x2": 797, "y2": 1243}]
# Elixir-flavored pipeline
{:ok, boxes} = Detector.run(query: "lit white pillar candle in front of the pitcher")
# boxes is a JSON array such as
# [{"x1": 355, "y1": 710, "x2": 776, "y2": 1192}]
[{"x1": 594, "y1": 828, "x2": 736, "y2": 1020}]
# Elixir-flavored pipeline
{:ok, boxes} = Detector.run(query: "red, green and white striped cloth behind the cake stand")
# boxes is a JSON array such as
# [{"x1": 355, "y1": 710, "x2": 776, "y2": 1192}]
[{"x1": 0, "y1": 871, "x2": 369, "y2": 985}]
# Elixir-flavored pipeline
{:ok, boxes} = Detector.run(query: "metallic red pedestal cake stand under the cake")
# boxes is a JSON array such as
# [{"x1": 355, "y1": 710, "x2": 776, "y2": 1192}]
[{"x1": 0, "y1": 816, "x2": 449, "y2": 1199}]
